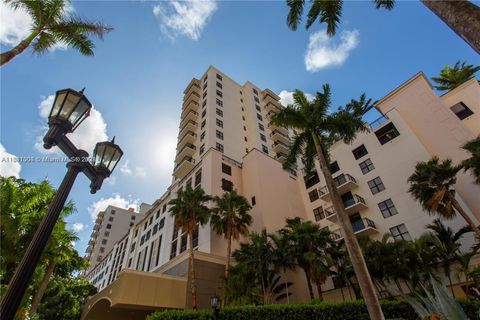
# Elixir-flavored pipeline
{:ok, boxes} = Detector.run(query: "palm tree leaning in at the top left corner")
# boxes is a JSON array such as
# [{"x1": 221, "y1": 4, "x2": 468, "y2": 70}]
[{"x1": 0, "y1": 0, "x2": 113, "y2": 66}]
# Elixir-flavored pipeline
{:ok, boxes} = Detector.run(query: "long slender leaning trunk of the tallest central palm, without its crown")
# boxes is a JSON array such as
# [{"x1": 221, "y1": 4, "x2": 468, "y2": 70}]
[{"x1": 312, "y1": 133, "x2": 385, "y2": 320}]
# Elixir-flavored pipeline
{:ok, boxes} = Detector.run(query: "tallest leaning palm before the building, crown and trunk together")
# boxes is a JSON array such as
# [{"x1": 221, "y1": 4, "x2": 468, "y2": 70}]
[{"x1": 273, "y1": 84, "x2": 384, "y2": 320}]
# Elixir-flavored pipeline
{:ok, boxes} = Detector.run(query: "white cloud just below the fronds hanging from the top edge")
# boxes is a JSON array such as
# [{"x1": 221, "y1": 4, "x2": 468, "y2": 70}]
[{"x1": 305, "y1": 30, "x2": 360, "y2": 72}]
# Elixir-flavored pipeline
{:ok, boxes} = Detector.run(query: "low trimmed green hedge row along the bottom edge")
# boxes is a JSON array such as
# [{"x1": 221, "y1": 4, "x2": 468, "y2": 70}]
[{"x1": 146, "y1": 300, "x2": 480, "y2": 320}]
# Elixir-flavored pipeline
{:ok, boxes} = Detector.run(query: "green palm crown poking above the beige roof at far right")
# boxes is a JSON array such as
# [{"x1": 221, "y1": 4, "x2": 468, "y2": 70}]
[{"x1": 432, "y1": 61, "x2": 480, "y2": 91}]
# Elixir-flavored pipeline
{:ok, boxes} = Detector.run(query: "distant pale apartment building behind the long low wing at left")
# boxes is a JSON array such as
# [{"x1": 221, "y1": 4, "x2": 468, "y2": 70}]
[{"x1": 86, "y1": 203, "x2": 149, "y2": 272}]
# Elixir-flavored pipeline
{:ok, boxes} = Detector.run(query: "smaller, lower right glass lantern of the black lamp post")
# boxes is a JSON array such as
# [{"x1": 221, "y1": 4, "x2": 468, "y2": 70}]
[{"x1": 93, "y1": 137, "x2": 123, "y2": 177}]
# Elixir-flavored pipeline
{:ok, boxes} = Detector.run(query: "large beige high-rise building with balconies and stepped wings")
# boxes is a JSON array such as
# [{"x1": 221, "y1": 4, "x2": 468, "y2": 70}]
[{"x1": 83, "y1": 67, "x2": 480, "y2": 319}]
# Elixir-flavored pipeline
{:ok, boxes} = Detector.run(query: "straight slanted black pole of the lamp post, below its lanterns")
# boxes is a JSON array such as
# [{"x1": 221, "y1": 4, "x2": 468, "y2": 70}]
[{"x1": 0, "y1": 162, "x2": 83, "y2": 320}]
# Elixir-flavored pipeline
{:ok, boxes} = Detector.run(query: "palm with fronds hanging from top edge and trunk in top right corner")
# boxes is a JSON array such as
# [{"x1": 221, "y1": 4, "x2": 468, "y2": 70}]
[{"x1": 287, "y1": 0, "x2": 480, "y2": 53}]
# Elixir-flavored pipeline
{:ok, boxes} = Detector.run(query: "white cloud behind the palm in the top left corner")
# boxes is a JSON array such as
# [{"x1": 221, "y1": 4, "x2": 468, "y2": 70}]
[{"x1": 0, "y1": 1, "x2": 75, "y2": 51}]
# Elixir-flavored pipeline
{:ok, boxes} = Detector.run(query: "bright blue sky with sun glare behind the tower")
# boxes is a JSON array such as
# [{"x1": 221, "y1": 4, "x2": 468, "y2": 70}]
[{"x1": 0, "y1": 1, "x2": 480, "y2": 253}]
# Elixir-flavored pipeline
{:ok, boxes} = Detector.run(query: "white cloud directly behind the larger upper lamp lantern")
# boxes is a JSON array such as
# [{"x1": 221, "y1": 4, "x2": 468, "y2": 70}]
[{"x1": 35, "y1": 95, "x2": 108, "y2": 155}]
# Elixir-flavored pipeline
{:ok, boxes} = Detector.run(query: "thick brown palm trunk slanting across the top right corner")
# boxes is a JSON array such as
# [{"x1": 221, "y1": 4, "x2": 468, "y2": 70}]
[{"x1": 421, "y1": 0, "x2": 480, "y2": 54}]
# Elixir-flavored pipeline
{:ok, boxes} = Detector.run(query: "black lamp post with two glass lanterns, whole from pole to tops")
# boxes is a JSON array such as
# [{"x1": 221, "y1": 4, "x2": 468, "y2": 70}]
[{"x1": 0, "y1": 89, "x2": 123, "y2": 320}]
